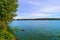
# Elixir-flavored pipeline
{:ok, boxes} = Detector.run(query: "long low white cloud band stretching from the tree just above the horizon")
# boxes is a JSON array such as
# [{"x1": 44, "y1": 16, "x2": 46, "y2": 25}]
[{"x1": 14, "y1": 13, "x2": 56, "y2": 19}]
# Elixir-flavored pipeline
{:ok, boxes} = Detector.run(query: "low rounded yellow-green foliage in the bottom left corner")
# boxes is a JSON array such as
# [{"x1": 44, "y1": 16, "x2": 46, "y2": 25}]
[{"x1": 0, "y1": 30, "x2": 15, "y2": 40}]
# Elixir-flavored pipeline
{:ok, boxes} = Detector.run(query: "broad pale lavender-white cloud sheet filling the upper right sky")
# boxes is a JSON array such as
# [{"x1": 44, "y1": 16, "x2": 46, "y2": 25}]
[{"x1": 22, "y1": 0, "x2": 60, "y2": 13}]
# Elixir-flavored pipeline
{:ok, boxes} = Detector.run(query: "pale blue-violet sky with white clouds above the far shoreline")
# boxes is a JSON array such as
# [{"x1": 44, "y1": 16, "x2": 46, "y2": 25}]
[{"x1": 15, "y1": 0, "x2": 60, "y2": 18}]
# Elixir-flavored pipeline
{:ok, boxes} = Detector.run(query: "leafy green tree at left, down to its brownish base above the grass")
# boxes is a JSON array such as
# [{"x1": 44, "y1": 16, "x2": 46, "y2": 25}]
[{"x1": 0, "y1": 0, "x2": 18, "y2": 39}]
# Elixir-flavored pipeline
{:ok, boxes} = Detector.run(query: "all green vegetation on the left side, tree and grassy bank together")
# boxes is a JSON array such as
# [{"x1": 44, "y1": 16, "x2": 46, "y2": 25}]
[{"x1": 0, "y1": 0, "x2": 18, "y2": 40}]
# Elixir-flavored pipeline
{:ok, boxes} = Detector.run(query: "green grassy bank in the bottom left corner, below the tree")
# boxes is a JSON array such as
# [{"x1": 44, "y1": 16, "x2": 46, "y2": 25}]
[{"x1": 0, "y1": 27, "x2": 17, "y2": 40}]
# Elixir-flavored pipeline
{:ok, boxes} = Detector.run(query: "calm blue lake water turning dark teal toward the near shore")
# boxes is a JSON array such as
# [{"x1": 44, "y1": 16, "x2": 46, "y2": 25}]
[{"x1": 10, "y1": 20, "x2": 60, "y2": 40}]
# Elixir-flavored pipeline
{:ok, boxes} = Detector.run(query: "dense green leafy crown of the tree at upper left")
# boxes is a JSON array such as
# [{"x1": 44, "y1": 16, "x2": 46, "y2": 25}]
[{"x1": 0, "y1": 0, "x2": 18, "y2": 22}]
